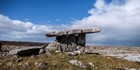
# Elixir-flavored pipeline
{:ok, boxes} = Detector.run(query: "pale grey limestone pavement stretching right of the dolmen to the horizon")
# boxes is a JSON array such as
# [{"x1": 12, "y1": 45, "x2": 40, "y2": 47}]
[{"x1": 86, "y1": 46, "x2": 140, "y2": 62}]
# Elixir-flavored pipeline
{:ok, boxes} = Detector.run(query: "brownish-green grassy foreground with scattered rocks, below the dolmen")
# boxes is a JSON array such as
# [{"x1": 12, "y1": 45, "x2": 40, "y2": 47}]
[{"x1": 0, "y1": 53, "x2": 140, "y2": 70}]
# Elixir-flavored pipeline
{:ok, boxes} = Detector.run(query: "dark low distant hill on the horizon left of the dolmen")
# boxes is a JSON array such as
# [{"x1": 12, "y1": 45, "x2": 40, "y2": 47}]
[{"x1": 0, "y1": 41, "x2": 49, "y2": 46}]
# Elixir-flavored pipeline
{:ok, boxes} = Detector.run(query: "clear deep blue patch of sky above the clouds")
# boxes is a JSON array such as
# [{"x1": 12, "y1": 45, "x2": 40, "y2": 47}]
[{"x1": 0, "y1": 0, "x2": 95, "y2": 24}]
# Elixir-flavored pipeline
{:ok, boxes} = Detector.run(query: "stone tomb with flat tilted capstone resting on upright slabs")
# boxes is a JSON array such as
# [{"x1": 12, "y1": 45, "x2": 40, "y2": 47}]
[{"x1": 46, "y1": 28, "x2": 101, "y2": 51}]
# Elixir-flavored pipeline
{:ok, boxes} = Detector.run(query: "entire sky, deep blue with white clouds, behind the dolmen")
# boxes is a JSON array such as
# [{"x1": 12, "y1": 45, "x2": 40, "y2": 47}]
[{"x1": 0, "y1": 0, "x2": 140, "y2": 46}]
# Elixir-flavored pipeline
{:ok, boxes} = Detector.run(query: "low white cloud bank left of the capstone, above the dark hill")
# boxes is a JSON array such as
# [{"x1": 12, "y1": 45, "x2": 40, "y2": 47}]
[{"x1": 0, "y1": 14, "x2": 53, "y2": 41}]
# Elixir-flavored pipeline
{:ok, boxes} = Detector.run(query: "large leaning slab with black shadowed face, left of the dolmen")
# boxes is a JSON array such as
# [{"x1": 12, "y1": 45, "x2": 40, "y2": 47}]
[{"x1": 9, "y1": 47, "x2": 41, "y2": 56}]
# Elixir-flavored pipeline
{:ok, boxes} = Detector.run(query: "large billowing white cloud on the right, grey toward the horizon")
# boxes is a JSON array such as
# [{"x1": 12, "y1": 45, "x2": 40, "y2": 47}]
[{"x1": 72, "y1": 0, "x2": 140, "y2": 45}]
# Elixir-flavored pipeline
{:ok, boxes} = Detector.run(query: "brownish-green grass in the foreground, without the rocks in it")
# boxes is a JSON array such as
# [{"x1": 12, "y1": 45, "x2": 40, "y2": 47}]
[{"x1": 0, "y1": 53, "x2": 140, "y2": 70}]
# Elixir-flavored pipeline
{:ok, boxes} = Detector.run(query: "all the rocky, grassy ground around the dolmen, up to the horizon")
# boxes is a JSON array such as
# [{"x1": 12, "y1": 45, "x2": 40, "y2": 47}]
[{"x1": 0, "y1": 41, "x2": 140, "y2": 70}]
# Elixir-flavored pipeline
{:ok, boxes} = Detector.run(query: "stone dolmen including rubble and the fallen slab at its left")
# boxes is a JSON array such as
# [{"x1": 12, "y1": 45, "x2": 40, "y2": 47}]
[{"x1": 9, "y1": 28, "x2": 101, "y2": 56}]
